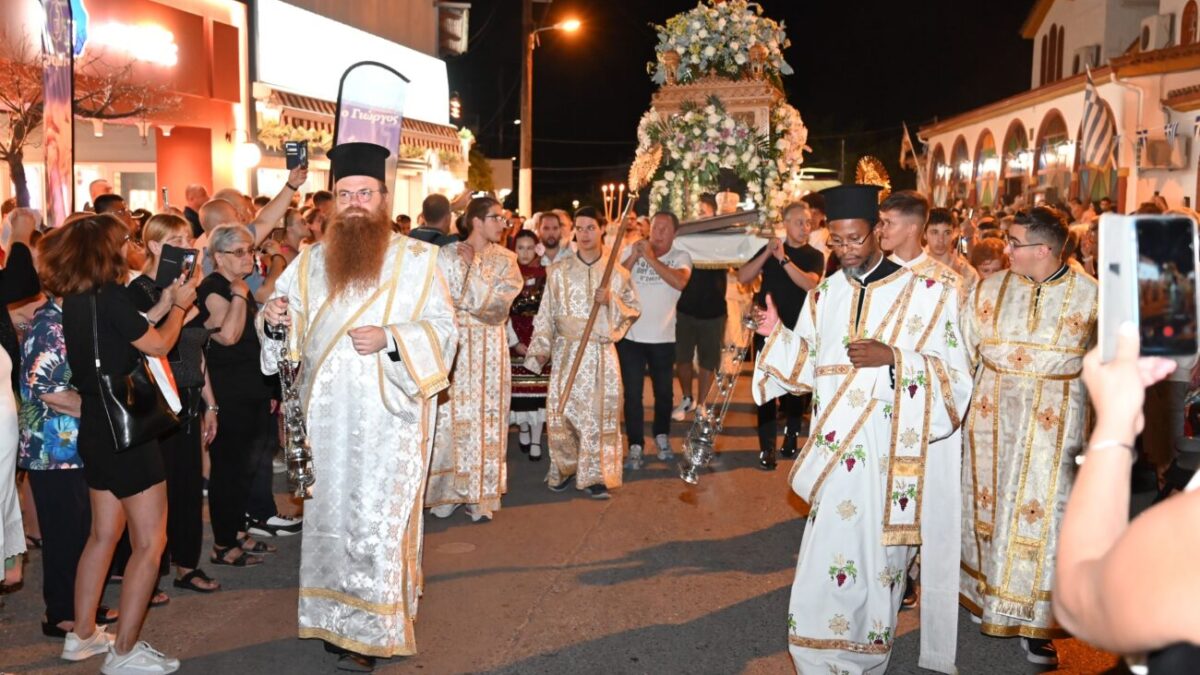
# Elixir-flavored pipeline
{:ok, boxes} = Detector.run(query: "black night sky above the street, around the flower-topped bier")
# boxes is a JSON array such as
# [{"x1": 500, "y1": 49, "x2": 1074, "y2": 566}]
[{"x1": 448, "y1": 0, "x2": 1033, "y2": 209}]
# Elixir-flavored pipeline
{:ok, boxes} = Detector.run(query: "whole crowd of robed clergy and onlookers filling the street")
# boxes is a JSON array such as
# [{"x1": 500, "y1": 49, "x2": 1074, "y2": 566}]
[{"x1": 0, "y1": 136, "x2": 1200, "y2": 674}]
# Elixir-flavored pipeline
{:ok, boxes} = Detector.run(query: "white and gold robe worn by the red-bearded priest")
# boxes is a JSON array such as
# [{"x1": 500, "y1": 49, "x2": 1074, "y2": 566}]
[{"x1": 259, "y1": 235, "x2": 457, "y2": 657}]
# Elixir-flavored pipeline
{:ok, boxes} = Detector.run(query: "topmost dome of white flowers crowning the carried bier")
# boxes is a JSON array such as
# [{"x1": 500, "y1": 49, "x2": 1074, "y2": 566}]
[{"x1": 648, "y1": 0, "x2": 793, "y2": 84}]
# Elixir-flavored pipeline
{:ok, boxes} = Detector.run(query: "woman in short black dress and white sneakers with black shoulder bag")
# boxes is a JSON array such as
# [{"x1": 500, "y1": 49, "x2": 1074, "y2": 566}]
[{"x1": 47, "y1": 215, "x2": 196, "y2": 675}]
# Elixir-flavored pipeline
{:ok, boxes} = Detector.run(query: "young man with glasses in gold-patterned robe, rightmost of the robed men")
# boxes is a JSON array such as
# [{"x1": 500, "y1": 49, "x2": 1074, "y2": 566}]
[{"x1": 961, "y1": 208, "x2": 1097, "y2": 664}]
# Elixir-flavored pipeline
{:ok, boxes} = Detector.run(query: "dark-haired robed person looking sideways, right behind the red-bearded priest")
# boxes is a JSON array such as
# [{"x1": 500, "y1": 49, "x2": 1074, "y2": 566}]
[{"x1": 425, "y1": 197, "x2": 524, "y2": 521}]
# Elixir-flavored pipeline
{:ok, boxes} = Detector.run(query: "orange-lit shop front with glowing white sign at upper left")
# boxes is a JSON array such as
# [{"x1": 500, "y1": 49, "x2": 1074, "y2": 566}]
[{"x1": 0, "y1": 0, "x2": 250, "y2": 209}]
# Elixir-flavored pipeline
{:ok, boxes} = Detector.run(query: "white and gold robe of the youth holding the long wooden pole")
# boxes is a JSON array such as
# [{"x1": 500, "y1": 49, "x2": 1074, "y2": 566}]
[{"x1": 526, "y1": 251, "x2": 641, "y2": 490}]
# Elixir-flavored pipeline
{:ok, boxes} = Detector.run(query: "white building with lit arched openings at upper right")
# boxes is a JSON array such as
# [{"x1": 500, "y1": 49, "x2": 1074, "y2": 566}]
[{"x1": 919, "y1": 0, "x2": 1200, "y2": 211}]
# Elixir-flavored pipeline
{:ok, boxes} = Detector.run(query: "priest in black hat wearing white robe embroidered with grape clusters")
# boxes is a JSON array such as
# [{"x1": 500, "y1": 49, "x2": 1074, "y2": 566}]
[{"x1": 752, "y1": 185, "x2": 971, "y2": 675}]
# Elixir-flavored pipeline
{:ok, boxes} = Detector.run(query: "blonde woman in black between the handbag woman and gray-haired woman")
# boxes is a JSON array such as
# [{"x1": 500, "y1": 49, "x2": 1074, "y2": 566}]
[{"x1": 130, "y1": 214, "x2": 221, "y2": 593}]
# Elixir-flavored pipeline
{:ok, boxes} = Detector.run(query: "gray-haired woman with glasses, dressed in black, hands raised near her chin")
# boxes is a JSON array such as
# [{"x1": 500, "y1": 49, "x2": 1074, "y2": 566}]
[{"x1": 192, "y1": 225, "x2": 275, "y2": 567}]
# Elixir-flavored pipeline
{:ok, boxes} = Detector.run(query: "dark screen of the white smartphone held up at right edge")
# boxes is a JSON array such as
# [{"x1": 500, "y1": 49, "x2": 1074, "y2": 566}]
[{"x1": 1135, "y1": 217, "x2": 1196, "y2": 356}]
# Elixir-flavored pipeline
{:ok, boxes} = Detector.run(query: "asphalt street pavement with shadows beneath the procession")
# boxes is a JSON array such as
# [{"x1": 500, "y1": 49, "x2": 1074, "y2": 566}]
[{"x1": 0, "y1": 376, "x2": 1116, "y2": 675}]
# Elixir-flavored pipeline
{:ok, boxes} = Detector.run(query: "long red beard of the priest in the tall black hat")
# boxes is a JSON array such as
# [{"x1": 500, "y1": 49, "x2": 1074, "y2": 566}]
[{"x1": 322, "y1": 207, "x2": 391, "y2": 298}]
